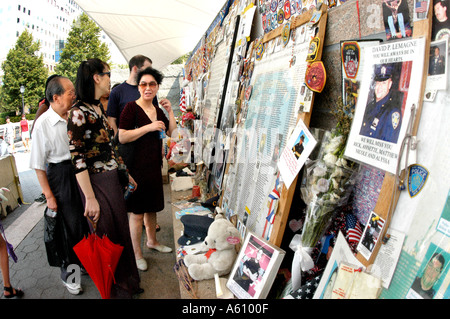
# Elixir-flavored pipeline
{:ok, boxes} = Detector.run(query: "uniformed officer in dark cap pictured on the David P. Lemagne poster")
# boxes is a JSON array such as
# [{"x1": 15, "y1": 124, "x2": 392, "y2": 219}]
[{"x1": 359, "y1": 64, "x2": 403, "y2": 143}]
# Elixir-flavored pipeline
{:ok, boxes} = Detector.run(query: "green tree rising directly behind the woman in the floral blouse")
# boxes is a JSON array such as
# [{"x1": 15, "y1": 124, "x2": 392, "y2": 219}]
[{"x1": 55, "y1": 13, "x2": 111, "y2": 83}]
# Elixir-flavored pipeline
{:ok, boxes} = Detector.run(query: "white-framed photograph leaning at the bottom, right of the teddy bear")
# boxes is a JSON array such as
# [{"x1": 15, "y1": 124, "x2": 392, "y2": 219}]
[{"x1": 227, "y1": 232, "x2": 285, "y2": 299}]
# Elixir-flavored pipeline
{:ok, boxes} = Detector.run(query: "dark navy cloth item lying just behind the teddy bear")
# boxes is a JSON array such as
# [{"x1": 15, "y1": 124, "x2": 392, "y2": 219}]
[{"x1": 178, "y1": 215, "x2": 214, "y2": 246}]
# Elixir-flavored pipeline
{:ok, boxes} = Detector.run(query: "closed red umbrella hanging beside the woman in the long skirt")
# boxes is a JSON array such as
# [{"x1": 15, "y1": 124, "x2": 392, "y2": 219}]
[{"x1": 73, "y1": 224, "x2": 123, "y2": 299}]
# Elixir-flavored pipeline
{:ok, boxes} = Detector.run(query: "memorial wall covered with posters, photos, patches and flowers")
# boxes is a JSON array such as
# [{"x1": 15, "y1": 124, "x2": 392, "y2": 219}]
[{"x1": 171, "y1": 0, "x2": 450, "y2": 299}]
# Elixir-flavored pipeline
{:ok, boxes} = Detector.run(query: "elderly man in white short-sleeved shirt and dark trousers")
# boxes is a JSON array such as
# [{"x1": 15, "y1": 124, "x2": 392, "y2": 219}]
[{"x1": 30, "y1": 76, "x2": 89, "y2": 294}]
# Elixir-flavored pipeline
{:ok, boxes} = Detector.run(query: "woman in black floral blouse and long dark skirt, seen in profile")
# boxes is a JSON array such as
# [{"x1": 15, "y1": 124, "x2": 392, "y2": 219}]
[{"x1": 67, "y1": 59, "x2": 143, "y2": 298}]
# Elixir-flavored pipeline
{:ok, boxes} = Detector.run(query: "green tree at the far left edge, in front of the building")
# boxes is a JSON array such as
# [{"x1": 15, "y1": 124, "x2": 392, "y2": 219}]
[{"x1": 2, "y1": 30, "x2": 48, "y2": 112}]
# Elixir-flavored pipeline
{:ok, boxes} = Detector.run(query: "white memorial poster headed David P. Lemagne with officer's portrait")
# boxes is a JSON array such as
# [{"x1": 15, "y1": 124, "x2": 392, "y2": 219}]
[{"x1": 344, "y1": 38, "x2": 425, "y2": 174}]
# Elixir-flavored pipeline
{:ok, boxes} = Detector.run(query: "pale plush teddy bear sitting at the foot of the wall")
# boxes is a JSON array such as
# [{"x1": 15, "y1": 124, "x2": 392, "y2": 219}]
[{"x1": 184, "y1": 214, "x2": 241, "y2": 281}]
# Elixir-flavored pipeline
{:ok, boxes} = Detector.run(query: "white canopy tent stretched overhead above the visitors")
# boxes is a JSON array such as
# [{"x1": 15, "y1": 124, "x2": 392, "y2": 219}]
[{"x1": 75, "y1": 0, "x2": 227, "y2": 69}]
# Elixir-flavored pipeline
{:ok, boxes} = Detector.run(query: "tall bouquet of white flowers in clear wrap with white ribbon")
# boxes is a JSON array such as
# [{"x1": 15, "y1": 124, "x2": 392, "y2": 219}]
[{"x1": 289, "y1": 99, "x2": 359, "y2": 290}]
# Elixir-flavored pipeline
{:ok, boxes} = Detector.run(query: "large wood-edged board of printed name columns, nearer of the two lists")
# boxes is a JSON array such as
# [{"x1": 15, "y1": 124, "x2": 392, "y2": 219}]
[{"x1": 221, "y1": 6, "x2": 327, "y2": 246}]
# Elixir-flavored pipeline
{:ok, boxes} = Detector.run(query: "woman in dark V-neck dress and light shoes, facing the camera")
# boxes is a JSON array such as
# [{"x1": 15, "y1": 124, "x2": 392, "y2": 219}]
[{"x1": 119, "y1": 67, "x2": 177, "y2": 271}]
